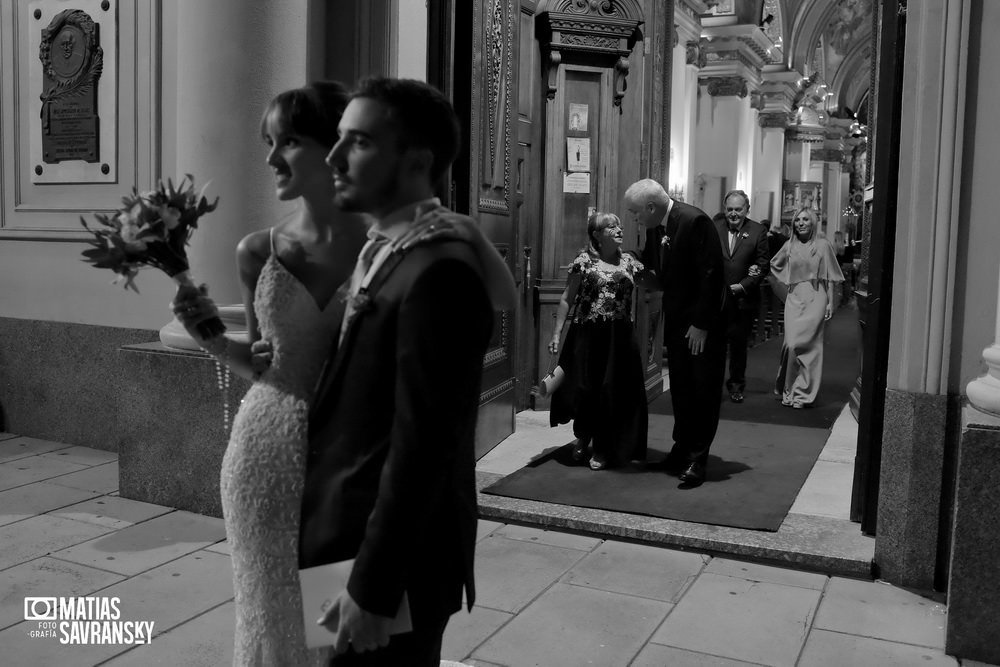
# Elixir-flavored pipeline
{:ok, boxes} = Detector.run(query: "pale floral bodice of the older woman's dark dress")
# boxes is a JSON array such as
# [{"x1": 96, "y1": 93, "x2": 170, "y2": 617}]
[{"x1": 569, "y1": 251, "x2": 643, "y2": 323}]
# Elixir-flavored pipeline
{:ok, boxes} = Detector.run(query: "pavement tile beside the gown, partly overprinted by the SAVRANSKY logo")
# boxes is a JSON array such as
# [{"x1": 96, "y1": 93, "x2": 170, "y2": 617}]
[{"x1": 88, "y1": 551, "x2": 234, "y2": 644}]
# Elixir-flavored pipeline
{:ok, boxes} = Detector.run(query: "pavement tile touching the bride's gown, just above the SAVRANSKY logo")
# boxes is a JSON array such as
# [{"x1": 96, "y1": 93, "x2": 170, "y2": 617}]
[{"x1": 55, "y1": 511, "x2": 228, "y2": 575}]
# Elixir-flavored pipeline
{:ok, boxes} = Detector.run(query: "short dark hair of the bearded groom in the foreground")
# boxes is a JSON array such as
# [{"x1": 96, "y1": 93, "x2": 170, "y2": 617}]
[{"x1": 351, "y1": 77, "x2": 462, "y2": 183}]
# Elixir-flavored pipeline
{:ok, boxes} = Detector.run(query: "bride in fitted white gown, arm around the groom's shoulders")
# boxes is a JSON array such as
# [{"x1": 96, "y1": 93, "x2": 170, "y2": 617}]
[{"x1": 173, "y1": 82, "x2": 516, "y2": 667}]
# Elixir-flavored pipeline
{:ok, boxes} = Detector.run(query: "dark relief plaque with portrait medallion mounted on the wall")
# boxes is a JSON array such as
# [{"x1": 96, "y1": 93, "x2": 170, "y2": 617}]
[{"x1": 38, "y1": 9, "x2": 104, "y2": 164}]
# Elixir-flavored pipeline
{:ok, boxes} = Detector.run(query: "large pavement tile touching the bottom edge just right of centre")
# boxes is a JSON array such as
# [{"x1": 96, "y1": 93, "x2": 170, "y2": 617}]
[{"x1": 472, "y1": 584, "x2": 672, "y2": 667}]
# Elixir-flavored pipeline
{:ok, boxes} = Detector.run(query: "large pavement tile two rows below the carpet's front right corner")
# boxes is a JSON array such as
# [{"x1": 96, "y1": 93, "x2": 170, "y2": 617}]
[{"x1": 651, "y1": 574, "x2": 820, "y2": 667}]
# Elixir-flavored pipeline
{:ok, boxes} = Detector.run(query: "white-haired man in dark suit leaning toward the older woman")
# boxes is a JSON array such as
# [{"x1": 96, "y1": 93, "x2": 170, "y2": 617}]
[{"x1": 625, "y1": 178, "x2": 726, "y2": 486}]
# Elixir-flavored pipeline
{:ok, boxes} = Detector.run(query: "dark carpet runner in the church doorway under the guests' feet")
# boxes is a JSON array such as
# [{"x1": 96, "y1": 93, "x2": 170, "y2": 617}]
[{"x1": 483, "y1": 308, "x2": 860, "y2": 531}]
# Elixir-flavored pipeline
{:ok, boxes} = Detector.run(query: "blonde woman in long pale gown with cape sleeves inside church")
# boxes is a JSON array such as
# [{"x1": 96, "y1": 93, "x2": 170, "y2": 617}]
[{"x1": 771, "y1": 208, "x2": 844, "y2": 408}]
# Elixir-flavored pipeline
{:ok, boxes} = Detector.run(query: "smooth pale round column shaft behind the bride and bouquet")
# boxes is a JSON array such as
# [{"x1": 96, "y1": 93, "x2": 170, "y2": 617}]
[{"x1": 172, "y1": 0, "x2": 310, "y2": 303}]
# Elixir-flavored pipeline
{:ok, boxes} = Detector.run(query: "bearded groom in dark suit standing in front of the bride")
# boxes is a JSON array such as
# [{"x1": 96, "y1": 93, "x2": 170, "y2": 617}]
[{"x1": 299, "y1": 79, "x2": 493, "y2": 667}]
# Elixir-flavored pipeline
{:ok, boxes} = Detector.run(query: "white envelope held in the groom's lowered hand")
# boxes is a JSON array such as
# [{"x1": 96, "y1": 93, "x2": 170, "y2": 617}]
[{"x1": 299, "y1": 558, "x2": 413, "y2": 648}]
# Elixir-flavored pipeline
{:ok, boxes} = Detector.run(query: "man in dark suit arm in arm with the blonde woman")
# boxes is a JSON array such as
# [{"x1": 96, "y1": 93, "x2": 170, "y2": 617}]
[{"x1": 715, "y1": 190, "x2": 770, "y2": 403}]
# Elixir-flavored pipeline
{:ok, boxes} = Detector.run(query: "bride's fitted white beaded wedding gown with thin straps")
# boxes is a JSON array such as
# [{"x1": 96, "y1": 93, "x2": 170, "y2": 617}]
[{"x1": 221, "y1": 243, "x2": 343, "y2": 667}]
